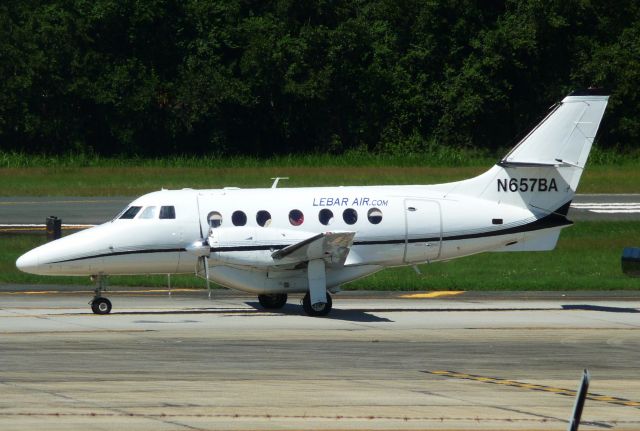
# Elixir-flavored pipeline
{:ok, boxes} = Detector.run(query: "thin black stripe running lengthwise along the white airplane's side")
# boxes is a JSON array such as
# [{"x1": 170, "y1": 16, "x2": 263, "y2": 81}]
[{"x1": 45, "y1": 206, "x2": 573, "y2": 265}]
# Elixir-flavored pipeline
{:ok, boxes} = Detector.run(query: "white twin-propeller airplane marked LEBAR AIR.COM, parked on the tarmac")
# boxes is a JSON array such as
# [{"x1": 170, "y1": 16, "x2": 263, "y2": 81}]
[{"x1": 16, "y1": 89, "x2": 608, "y2": 316}]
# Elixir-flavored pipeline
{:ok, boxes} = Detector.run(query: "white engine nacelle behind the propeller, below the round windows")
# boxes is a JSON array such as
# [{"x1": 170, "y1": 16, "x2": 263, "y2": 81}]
[{"x1": 208, "y1": 227, "x2": 315, "y2": 268}]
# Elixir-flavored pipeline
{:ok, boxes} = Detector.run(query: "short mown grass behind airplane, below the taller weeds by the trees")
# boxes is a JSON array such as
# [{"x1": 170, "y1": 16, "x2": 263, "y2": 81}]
[{"x1": 0, "y1": 163, "x2": 640, "y2": 196}]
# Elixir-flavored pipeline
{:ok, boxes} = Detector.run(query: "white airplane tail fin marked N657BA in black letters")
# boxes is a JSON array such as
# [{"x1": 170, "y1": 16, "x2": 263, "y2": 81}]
[{"x1": 452, "y1": 90, "x2": 609, "y2": 214}]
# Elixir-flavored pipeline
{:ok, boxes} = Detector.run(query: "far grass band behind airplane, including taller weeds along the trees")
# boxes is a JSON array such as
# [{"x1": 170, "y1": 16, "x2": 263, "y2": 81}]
[{"x1": 0, "y1": 145, "x2": 640, "y2": 196}]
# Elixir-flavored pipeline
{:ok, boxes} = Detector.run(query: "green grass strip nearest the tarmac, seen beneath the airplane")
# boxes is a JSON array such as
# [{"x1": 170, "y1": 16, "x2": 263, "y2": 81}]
[{"x1": 0, "y1": 221, "x2": 640, "y2": 291}]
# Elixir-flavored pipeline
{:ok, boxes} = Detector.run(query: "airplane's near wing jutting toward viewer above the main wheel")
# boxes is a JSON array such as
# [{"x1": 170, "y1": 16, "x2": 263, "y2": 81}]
[{"x1": 271, "y1": 232, "x2": 356, "y2": 266}]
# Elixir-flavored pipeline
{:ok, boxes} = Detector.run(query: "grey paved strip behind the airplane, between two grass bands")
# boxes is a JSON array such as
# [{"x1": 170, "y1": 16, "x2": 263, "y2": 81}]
[{"x1": 0, "y1": 194, "x2": 640, "y2": 230}]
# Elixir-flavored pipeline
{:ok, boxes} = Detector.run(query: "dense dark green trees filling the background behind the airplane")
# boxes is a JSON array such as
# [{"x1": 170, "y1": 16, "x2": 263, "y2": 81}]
[{"x1": 0, "y1": 0, "x2": 640, "y2": 156}]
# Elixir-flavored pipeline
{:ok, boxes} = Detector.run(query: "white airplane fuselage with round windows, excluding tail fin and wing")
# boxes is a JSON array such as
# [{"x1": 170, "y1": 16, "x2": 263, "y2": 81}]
[{"x1": 13, "y1": 182, "x2": 566, "y2": 293}]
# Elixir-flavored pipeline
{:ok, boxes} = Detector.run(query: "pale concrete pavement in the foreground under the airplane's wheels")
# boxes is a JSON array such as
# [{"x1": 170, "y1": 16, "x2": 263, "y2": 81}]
[{"x1": 0, "y1": 285, "x2": 640, "y2": 430}]
